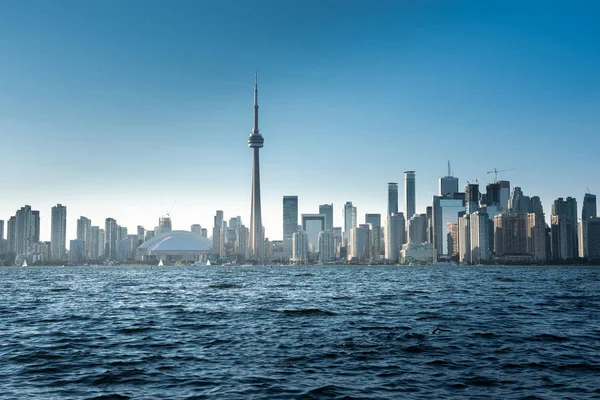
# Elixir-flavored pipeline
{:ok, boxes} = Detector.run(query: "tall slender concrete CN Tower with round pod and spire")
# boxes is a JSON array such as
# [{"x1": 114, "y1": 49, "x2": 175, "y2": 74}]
[{"x1": 248, "y1": 73, "x2": 265, "y2": 261}]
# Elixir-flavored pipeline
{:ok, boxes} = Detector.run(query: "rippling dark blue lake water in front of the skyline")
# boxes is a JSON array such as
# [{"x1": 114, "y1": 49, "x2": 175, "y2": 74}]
[{"x1": 0, "y1": 266, "x2": 600, "y2": 399}]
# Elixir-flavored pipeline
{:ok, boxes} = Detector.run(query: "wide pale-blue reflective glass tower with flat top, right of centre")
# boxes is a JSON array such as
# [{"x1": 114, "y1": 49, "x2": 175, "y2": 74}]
[{"x1": 432, "y1": 194, "x2": 465, "y2": 259}]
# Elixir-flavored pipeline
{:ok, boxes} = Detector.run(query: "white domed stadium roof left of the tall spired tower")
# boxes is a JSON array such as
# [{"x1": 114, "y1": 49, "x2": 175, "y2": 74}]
[{"x1": 138, "y1": 231, "x2": 212, "y2": 254}]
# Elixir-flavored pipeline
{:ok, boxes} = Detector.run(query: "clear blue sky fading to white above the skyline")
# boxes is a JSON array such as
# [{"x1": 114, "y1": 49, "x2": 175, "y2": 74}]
[{"x1": 0, "y1": 0, "x2": 600, "y2": 239}]
